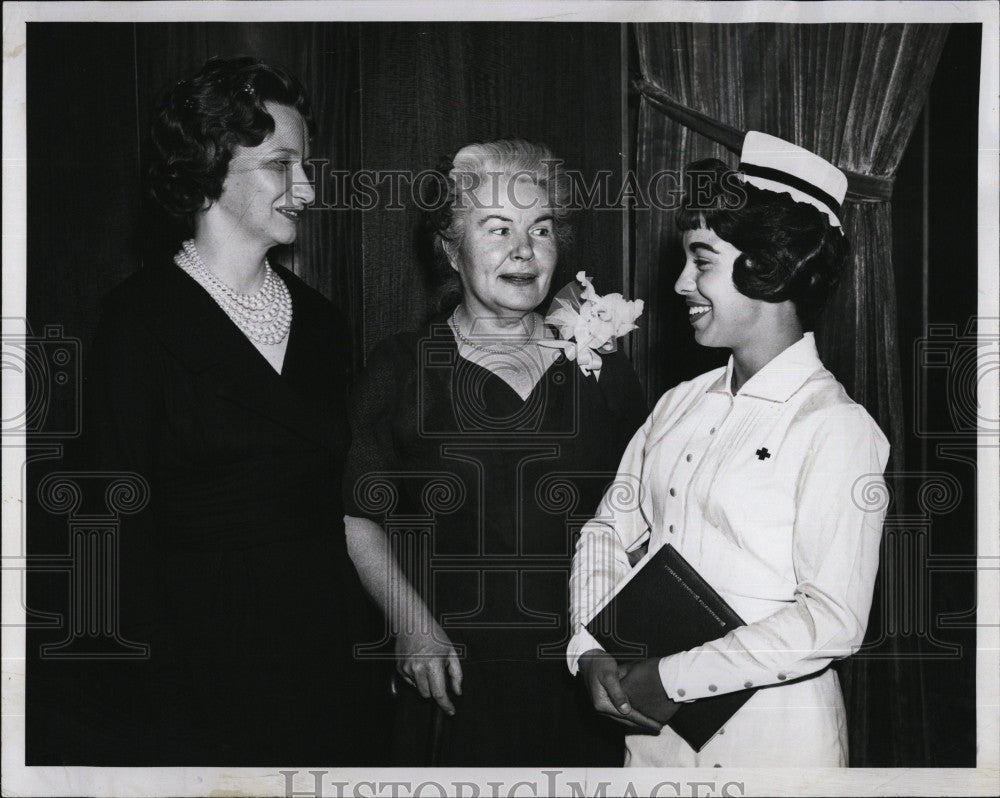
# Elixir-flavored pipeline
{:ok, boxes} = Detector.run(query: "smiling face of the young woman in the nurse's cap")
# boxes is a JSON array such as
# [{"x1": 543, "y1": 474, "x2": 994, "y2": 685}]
[{"x1": 674, "y1": 227, "x2": 776, "y2": 353}]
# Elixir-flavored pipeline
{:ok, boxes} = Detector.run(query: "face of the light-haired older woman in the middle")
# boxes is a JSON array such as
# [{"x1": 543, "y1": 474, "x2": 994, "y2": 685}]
[{"x1": 446, "y1": 178, "x2": 558, "y2": 318}]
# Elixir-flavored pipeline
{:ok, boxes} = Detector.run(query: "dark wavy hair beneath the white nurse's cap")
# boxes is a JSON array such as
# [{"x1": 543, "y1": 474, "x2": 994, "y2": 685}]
[{"x1": 677, "y1": 158, "x2": 850, "y2": 330}]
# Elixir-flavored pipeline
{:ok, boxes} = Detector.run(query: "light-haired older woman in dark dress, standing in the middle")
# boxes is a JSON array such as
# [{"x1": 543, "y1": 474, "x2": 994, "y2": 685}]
[{"x1": 345, "y1": 140, "x2": 646, "y2": 767}]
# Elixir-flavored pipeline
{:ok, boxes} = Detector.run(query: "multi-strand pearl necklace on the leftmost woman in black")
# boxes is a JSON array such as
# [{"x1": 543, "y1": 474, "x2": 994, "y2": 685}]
[{"x1": 174, "y1": 239, "x2": 292, "y2": 346}]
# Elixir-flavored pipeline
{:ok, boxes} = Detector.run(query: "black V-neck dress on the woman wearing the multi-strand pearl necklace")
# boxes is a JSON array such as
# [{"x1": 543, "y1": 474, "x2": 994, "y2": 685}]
[{"x1": 78, "y1": 264, "x2": 378, "y2": 766}]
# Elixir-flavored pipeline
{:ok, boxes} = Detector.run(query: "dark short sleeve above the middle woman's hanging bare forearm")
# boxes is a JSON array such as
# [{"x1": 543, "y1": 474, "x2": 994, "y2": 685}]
[{"x1": 343, "y1": 337, "x2": 415, "y2": 524}]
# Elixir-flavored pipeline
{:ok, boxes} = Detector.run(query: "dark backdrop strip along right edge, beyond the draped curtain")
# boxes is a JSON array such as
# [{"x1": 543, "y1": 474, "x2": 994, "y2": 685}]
[{"x1": 888, "y1": 24, "x2": 980, "y2": 767}]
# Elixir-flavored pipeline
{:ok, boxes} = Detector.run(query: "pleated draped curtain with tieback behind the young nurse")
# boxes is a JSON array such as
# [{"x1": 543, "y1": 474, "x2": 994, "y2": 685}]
[{"x1": 633, "y1": 23, "x2": 947, "y2": 766}]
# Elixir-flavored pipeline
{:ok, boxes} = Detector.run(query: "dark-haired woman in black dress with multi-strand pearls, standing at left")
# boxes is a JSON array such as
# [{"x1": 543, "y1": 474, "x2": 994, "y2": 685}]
[{"x1": 81, "y1": 58, "x2": 367, "y2": 766}]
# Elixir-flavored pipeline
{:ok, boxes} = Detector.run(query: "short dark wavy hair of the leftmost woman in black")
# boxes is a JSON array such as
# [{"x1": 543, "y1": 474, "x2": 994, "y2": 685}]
[{"x1": 147, "y1": 56, "x2": 315, "y2": 226}]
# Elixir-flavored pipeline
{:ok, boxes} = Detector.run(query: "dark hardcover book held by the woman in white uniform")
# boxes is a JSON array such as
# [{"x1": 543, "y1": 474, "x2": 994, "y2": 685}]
[{"x1": 587, "y1": 544, "x2": 755, "y2": 751}]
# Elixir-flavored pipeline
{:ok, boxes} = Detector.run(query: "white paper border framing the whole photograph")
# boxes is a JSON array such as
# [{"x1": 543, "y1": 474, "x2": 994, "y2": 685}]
[{"x1": 0, "y1": 0, "x2": 1000, "y2": 798}]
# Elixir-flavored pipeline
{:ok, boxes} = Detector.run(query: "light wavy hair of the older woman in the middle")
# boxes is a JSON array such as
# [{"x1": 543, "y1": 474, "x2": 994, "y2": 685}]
[{"x1": 416, "y1": 139, "x2": 573, "y2": 308}]
